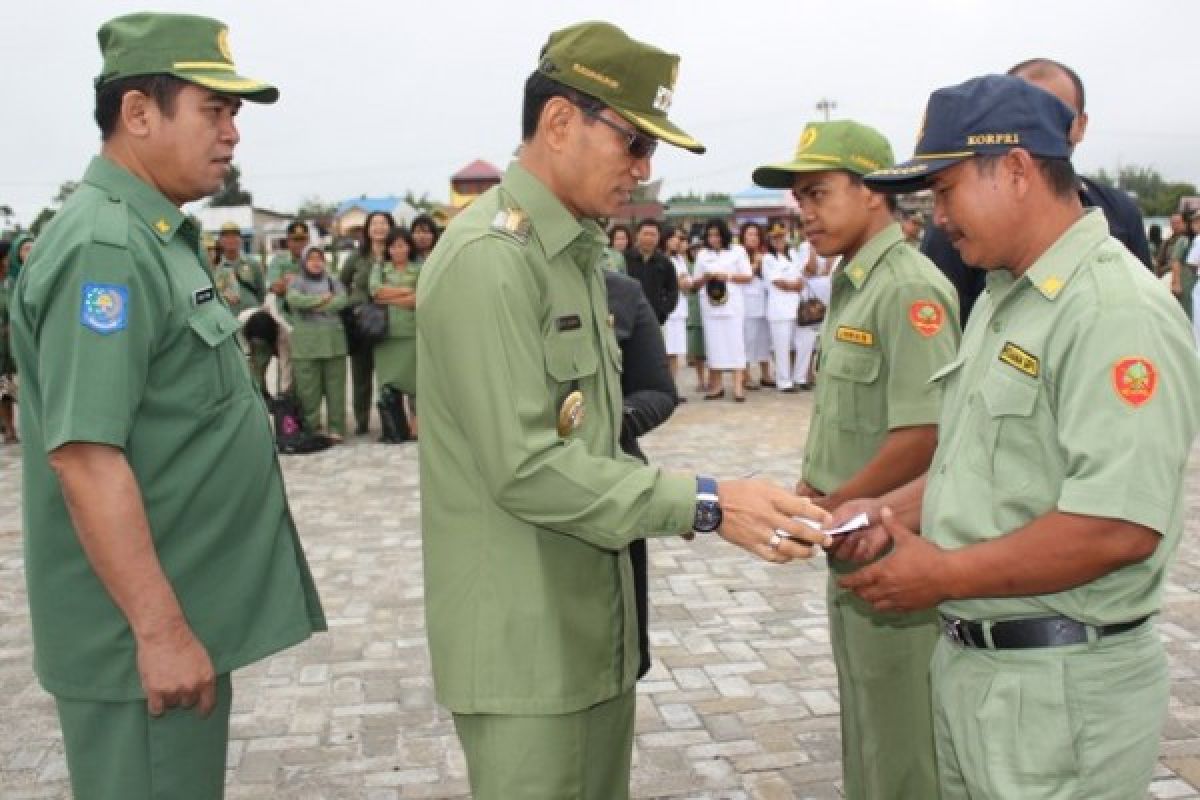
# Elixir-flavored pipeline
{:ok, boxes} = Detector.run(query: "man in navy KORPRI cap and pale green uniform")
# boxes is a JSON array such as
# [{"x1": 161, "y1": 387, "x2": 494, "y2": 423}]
[{"x1": 839, "y1": 76, "x2": 1200, "y2": 800}]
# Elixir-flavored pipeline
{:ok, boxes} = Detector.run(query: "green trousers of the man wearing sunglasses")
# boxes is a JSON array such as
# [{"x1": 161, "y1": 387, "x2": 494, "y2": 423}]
[{"x1": 454, "y1": 690, "x2": 635, "y2": 800}]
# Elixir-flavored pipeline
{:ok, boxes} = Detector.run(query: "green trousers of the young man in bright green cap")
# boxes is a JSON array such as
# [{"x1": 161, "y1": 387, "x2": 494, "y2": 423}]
[{"x1": 828, "y1": 567, "x2": 940, "y2": 800}]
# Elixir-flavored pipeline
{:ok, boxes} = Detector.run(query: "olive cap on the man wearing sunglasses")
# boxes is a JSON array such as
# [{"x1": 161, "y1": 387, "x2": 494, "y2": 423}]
[{"x1": 538, "y1": 22, "x2": 704, "y2": 152}]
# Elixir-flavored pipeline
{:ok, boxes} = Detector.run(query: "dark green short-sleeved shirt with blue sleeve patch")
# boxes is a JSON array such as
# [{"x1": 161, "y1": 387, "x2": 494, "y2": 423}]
[{"x1": 12, "y1": 157, "x2": 325, "y2": 700}]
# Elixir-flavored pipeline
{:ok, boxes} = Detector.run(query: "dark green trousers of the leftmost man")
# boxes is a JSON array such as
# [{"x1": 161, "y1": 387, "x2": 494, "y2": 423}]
[{"x1": 55, "y1": 675, "x2": 233, "y2": 800}]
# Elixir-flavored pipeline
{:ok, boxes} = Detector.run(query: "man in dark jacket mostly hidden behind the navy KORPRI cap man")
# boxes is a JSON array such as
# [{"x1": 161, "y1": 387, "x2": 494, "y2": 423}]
[{"x1": 920, "y1": 59, "x2": 1154, "y2": 326}]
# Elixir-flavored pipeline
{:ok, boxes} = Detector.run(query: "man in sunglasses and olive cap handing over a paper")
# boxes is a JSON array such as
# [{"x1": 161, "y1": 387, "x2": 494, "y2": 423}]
[{"x1": 416, "y1": 23, "x2": 827, "y2": 800}]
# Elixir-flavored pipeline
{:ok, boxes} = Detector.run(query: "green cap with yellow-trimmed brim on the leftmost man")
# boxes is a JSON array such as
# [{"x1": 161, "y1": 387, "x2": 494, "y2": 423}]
[{"x1": 96, "y1": 12, "x2": 280, "y2": 103}]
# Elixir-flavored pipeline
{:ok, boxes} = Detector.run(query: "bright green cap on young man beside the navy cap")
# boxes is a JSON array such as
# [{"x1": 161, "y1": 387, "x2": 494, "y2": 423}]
[{"x1": 754, "y1": 120, "x2": 895, "y2": 188}]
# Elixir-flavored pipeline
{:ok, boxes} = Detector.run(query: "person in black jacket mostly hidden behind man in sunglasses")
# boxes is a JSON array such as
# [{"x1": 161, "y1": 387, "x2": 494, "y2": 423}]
[{"x1": 604, "y1": 270, "x2": 679, "y2": 678}]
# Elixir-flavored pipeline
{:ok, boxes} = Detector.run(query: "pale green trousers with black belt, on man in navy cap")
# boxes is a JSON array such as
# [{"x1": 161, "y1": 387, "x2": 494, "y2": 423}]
[{"x1": 932, "y1": 622, "x2": 1170, "y2": 800}]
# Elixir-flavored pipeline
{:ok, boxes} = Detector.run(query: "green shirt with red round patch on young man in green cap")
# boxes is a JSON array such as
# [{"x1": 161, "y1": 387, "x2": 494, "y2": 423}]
[{"x1": 804, "y1": 223, "x2": 959, "y2": 494}]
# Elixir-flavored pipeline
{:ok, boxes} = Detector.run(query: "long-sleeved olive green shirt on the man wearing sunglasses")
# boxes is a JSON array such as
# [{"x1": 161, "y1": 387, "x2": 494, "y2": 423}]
[{"x1": 416, "y1": 163, "x2": 696, "y2": 715}]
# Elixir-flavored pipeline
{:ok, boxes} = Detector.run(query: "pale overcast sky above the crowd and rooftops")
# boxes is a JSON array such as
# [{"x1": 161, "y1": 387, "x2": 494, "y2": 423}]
[{"x1": 0, "y1": 0, "x2": 1200, "y2": 224}]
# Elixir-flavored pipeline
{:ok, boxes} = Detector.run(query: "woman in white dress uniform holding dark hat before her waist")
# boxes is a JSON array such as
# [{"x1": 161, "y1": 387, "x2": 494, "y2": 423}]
[{"x1": 695, "y1": 219, "x2": 751, "y2": 403}]
